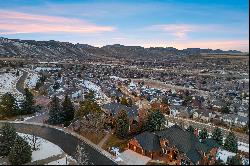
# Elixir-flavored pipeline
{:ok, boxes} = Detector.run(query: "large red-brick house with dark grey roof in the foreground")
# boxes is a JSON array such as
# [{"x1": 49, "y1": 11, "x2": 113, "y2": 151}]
[{"x1": 128, "y1": 125, "x2": 219, "y2": 165}]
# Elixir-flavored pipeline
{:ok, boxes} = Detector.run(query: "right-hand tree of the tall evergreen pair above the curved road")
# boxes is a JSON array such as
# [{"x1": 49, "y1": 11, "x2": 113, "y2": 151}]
[{"x1": 62, "y1": 94, "x2": 75, "y2": 126}]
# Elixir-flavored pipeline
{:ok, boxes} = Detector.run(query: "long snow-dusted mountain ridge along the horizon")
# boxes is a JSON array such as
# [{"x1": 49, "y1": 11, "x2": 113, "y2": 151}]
[{"x1": 0, "y1": 37, "x2": 242, "y2": 59}]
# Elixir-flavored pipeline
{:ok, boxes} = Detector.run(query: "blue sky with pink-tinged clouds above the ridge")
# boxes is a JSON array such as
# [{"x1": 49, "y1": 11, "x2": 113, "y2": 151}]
[{"x1": 0, "y1": 0, "x2": 249, "y2": 52}]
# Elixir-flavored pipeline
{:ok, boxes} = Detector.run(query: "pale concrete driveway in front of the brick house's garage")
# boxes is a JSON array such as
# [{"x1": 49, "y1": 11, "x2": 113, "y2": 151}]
[{"x1": 119, "y1": 150, "x2": 151, "y2": 165}]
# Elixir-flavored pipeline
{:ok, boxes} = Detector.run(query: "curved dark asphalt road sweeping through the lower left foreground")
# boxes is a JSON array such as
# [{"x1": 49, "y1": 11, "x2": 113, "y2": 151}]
[{"x1": 0, "y1": 121, "x2": 117, "y2": 165}]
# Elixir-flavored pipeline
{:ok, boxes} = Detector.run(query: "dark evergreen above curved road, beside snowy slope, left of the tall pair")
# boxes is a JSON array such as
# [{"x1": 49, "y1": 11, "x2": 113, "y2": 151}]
[{"x1": 21, "y1": 88, "x2": 35, "y2": 114}]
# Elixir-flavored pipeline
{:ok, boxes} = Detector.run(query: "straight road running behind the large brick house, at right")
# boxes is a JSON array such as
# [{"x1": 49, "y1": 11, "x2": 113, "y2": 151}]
[{"x1": 165, "y1": 115, "x2": 249, "y2": 144}]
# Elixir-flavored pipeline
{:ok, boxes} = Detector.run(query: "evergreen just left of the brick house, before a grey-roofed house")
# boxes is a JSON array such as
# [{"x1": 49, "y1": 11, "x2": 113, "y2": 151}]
[{"x1": 115, "y1": 110, "x2": 129, "y2": 138}]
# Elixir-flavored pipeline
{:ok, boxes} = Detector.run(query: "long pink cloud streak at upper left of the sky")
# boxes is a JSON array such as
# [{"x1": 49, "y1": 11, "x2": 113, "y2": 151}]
[{"x1": 0, "y1": 10, "x2": 115, "y2": 34}]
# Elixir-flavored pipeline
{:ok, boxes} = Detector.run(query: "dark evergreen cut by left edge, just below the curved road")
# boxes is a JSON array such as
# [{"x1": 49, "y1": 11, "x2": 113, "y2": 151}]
[{"x1": 0, "y1": 123, "x2": 17, "y2": 156}]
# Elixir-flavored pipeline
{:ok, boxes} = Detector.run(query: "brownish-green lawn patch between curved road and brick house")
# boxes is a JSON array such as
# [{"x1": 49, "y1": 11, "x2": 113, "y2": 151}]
[{"x1": 102, "y1": 134, "x2": 129, "y2": 151}]
